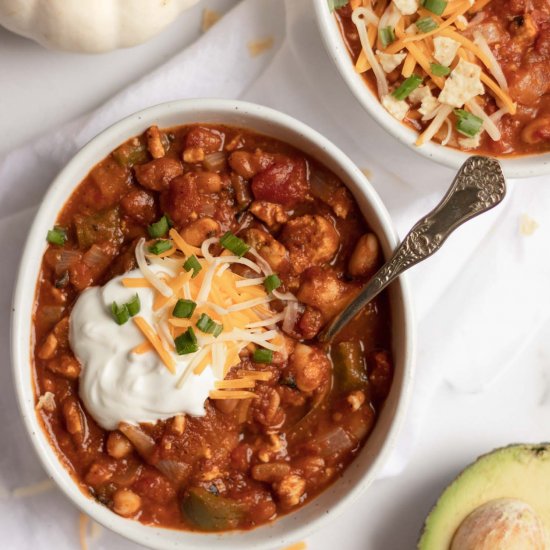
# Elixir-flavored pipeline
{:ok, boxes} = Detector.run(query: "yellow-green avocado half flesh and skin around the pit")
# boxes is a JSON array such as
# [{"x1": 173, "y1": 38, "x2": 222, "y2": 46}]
[{"x1": 418, "y1": 443, "x2": 550, "y2": 550}]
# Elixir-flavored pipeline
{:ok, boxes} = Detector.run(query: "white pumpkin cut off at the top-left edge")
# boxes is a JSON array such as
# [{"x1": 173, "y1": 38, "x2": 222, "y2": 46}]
[{"x1": 0, "y1": 0, "x2": 202, "y2": 53}]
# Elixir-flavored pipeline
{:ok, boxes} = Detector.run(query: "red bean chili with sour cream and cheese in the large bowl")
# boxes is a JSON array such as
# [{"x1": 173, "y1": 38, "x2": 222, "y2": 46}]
[{"x1": 33, "y1": 125, "x2": 393, "y2": 531}]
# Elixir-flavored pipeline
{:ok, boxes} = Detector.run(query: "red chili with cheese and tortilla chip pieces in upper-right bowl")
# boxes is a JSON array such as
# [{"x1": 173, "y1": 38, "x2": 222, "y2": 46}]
[{"x1": 328, "y1": 0, "x2": 550, "y2": 156}]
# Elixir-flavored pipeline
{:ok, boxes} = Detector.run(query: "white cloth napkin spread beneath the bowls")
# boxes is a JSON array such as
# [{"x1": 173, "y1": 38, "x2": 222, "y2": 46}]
[{"x1": 0, "y1": 0, "x2": 550, "y2": 549}]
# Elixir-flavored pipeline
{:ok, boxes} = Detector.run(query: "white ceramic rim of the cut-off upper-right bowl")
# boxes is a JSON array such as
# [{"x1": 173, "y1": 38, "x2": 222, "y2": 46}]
[{"x1": 311, "y1": 0, "x2": 550, "y2": 178}]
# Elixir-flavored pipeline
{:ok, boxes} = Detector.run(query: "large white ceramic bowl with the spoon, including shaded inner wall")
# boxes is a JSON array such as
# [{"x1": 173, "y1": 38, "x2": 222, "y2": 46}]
[{"x1": 11, "y1": 99, "x2": 414, "y2": 550}]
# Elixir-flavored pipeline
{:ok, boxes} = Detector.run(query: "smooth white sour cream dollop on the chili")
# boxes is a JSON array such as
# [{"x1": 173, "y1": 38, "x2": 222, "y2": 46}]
[{"x1": 69, "y1": 266, "x2": 216, "y2": 430}]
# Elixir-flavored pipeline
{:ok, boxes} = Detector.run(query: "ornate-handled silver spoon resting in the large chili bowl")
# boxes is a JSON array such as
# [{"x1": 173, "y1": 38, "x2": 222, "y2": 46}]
[{"x1": 319, "y1": 156, "x2": 506, "y2": 342}]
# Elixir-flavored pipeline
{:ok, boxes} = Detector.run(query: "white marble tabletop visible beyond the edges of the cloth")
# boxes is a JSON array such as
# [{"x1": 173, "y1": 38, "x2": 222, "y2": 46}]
[{"x1": 0, "y1": 0, "x2": 550, "y2": 550}]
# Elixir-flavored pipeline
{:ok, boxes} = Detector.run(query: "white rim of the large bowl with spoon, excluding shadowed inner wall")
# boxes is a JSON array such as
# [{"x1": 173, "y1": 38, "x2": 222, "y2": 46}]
[{"x1": 10, "y1": 99, "x2": 416, "y2": 550}]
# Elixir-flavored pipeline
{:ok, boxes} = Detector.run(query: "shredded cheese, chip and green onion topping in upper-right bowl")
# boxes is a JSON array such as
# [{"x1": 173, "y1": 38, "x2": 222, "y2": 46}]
[{"x1": 350, "y1": 0, "x2": 517, "y2": 148}]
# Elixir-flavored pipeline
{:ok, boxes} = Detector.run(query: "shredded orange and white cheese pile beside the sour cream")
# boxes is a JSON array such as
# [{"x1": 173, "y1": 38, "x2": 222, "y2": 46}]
[{"x1": 126, "y1": 229, "x2": 296, "y2": 399}]
